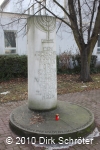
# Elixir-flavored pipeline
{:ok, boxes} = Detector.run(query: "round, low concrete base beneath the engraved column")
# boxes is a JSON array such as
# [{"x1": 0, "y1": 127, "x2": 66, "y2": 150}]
[{"x1": 10, "y1": 101, "x2": 94, "y2": 144}]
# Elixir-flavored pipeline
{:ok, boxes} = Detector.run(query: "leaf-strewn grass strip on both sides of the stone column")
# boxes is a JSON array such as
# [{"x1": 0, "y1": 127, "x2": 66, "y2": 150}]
[{"x1": 0, "y1": 74, "x2": 100, "y2": 103}]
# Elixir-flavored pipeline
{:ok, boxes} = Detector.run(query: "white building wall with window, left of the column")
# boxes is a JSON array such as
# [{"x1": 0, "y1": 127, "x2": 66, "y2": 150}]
[{"x1": 0, "y1": 13, "x2": 27, "y2": 55}]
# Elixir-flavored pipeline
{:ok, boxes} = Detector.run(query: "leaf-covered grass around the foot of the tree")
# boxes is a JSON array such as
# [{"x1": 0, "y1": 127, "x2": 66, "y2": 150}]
[{"x1": 58, "y1": 74, "x2": 100, "y2": 94}]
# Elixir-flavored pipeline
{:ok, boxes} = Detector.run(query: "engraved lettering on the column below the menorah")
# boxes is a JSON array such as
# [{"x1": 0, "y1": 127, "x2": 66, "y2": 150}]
[{"x1": 34, "y1": 47, "x2": 56, "y2": 100}]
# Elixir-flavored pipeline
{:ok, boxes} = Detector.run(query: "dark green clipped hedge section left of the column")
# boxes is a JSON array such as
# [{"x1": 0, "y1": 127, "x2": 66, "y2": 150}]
[{"x1": 0, "y1": 55, "x2": 27, "y2": 81}]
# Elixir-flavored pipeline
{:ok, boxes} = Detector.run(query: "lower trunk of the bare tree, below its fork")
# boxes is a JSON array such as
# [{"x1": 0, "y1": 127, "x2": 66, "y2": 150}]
[{"x1": 79, "y1": 47, "x2": 92, "y2": 82}]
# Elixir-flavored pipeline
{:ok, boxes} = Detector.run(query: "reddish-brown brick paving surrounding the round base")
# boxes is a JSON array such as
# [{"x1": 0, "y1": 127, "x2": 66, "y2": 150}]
[{"x1": 0, "y1": 90, "x2": 100, "y2": 150}]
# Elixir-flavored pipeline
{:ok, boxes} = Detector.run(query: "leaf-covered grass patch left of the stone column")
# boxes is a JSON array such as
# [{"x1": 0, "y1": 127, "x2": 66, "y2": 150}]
[{"x1": 0, "y1": 79, "x2": 28, "y2": 102}]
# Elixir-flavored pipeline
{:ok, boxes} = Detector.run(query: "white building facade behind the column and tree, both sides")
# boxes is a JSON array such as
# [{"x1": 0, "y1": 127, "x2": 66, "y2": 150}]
[{"x1": 0, "y1": 0, "x2": 100, "y2": 63}]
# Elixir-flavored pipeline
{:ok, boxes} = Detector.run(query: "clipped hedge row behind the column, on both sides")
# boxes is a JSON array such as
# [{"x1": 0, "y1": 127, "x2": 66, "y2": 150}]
[{"x1": 0, "y1": 55, "x2": 100, "y2": 82}]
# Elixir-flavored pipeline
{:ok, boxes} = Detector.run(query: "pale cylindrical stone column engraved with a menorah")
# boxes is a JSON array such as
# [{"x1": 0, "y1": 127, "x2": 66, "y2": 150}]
[{"x1": 28, "y1": 16, "x2": 57, "y2": 110}]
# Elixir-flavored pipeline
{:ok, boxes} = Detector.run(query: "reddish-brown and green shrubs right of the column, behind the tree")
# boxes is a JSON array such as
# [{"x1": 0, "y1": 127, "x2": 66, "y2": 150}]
[{"x1": 57, "y1": 53, "x2": 99, "y2": 74}]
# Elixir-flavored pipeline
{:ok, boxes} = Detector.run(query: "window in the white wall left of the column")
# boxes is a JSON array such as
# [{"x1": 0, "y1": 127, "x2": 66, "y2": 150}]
[{"x1": 4, "y1": 31, "x2": 16, "y2": 54}]
